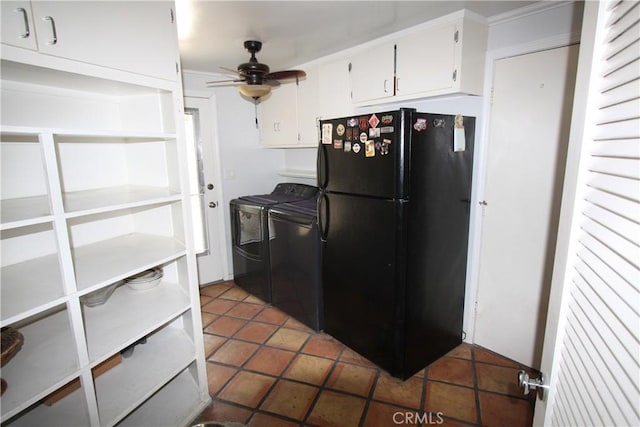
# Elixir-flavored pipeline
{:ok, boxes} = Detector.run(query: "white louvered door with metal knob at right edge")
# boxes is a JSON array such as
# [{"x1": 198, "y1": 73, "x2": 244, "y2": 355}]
[{"x1": 534, "y1": 1, "x2": 640, "y2": 426}]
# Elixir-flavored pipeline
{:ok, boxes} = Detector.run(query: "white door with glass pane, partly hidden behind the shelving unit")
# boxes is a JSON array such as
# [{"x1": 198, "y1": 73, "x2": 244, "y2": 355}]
[{"x1": 185, "y1": 97, "x2": 227, "y2": 285}]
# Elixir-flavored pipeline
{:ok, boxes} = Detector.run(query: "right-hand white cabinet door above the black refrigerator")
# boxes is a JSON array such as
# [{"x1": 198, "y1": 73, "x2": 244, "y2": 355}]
[{"x1": 396, "y1": 23, "x2": 457, "y2": 96}]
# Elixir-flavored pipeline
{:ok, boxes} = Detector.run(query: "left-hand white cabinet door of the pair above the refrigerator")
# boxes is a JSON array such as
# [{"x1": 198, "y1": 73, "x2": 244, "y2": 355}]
[{"x1": 351, "y1": 43, "x2": 395, "y2": 103}]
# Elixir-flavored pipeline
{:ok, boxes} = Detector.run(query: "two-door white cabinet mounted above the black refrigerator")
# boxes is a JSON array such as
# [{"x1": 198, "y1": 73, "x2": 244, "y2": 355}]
[{"x1": 350, "y1": 11, "x2": 487, "y2": 106}]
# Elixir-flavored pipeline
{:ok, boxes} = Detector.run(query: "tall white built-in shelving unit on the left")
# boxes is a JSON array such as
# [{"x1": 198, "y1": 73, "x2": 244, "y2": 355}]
[{"x1": 0, "y1": 1, "x2": 210, "y2": 426}]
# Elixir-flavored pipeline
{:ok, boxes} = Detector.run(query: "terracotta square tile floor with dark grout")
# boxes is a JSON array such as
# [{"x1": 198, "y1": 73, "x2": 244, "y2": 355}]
[{"x1": 196, "y1": 282, "x2": 534, "y2": 427}]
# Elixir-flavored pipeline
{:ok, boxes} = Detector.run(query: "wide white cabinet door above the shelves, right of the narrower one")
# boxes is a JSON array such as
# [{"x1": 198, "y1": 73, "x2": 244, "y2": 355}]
[{"x1": 32, "y1": 1, "x2": 178, "y2": 80}]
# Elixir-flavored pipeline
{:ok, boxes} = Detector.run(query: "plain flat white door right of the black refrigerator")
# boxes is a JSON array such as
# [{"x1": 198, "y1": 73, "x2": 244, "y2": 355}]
[{"x1": 474, "y1": 46, "x2": 578, "y2": 368}]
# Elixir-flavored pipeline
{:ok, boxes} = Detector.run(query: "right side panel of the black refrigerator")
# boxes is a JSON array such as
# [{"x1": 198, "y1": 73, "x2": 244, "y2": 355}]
[{"x1": 404, "y1": 114, "x2": 475, "y2": 375}]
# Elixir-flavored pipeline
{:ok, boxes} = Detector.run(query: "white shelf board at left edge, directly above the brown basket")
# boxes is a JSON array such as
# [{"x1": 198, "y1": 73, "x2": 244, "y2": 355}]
[{"x1": 0, "y1": 254, "x2": 64, "y2": 325}]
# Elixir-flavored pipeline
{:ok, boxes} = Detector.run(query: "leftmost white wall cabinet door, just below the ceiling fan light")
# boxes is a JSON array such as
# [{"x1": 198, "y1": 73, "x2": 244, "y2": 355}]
[{"x1": 260, "y1": 82, "x2": 298, "y2": 147}]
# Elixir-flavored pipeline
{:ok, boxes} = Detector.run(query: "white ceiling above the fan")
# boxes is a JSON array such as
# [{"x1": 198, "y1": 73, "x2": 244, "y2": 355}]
[{"x1": 177, "y1": 0, "x2": 534, "y2": 73}]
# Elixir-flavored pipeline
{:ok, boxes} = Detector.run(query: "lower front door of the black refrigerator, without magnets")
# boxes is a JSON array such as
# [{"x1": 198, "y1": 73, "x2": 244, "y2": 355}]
[{"x1": 319, "y1": 193, "x2": 405, "y2": 373}]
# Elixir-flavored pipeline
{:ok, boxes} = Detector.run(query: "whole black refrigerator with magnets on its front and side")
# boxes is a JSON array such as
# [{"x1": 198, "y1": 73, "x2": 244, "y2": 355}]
[{"x1": 317, "y1": 109, "x2": 475, "y2": 379}]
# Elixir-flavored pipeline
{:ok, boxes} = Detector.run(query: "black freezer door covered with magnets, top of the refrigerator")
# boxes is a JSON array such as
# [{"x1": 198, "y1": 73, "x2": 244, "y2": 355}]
[{"x1": 318, "y1": 109, "x2": 412, "y2": 199}]
